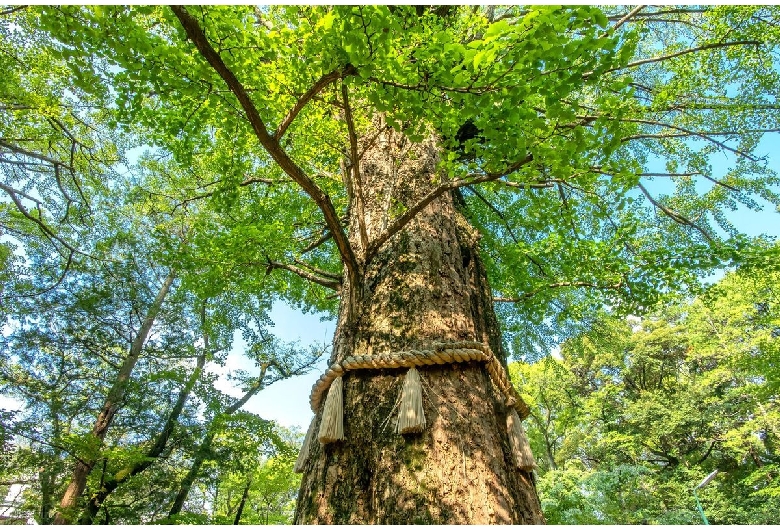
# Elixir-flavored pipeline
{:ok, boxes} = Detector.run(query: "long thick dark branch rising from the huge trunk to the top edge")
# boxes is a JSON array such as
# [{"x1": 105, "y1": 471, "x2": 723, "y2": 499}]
[{"x1": 171, "y1": 6, "x2": 361, "y2": 284}]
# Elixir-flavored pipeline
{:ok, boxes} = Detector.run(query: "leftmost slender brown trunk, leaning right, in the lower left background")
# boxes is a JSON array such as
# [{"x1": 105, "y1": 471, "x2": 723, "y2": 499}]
[{"x1": 54, "y1": 273, "x2": 174, "y2": 524}]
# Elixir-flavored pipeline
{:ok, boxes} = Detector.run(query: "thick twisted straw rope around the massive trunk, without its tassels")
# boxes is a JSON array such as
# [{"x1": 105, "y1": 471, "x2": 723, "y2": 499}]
[{"x1": 309, "y1": 341, "x2": 530, "y2": 420}]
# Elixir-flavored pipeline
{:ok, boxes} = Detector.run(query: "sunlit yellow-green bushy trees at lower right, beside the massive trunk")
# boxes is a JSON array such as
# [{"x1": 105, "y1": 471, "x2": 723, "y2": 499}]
[{"x1": 512, "y1": 262, "x2": 780, "y2": 524}]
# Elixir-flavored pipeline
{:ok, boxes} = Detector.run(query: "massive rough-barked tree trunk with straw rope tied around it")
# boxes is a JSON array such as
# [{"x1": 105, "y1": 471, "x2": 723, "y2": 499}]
[{"x1": 295, "y1": 126, "x2": 544, "y2": 524}]
